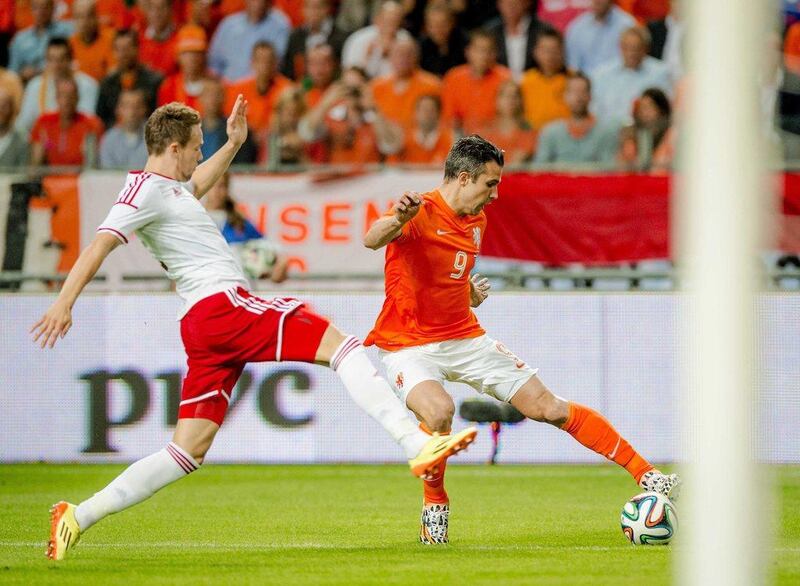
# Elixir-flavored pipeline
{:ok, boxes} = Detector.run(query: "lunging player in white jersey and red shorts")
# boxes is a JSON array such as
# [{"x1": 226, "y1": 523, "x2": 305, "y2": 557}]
[{"x1": 31, "y1": 95, "x2": 476, "y2": 560}]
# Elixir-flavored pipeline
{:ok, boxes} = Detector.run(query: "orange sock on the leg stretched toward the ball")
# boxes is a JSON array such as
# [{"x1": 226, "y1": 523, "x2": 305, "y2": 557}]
[{"x1": 561, "y1": 403, "x2": 653, "y2": 484}]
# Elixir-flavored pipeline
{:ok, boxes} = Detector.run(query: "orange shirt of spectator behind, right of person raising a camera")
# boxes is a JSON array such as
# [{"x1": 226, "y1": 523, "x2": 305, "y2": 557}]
[{"x1": 372, "y1": 69, "x2": 442, "y2": 127}]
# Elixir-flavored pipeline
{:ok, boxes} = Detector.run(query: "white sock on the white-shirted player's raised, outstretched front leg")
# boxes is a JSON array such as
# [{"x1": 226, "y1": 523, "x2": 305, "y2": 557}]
[{"x1": 332, "y1": 336, "x2": 430, "y2": 456}]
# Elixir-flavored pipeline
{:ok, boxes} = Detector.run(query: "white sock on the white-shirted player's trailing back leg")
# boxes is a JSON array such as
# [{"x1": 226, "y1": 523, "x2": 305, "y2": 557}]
[{"x1": 75, "y1": 442, "x2": 200, "y2": 531}]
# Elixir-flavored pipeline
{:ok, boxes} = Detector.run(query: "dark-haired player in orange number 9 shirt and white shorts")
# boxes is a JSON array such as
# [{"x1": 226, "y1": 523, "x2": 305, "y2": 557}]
[{"x1": 364, "y1": 135, "x2": 680, "y2": 544}]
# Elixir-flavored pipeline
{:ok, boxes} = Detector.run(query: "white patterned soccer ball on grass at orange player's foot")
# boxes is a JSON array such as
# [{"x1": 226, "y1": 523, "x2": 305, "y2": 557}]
[{"x1": 620, "y1": 492, "x2": 678, "y2": 545}]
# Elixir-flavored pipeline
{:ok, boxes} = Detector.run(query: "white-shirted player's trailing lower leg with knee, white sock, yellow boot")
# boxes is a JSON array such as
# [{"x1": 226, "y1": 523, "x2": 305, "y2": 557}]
[{"x1": 46, "y1": 419, "x2": 219, "y2": 560}]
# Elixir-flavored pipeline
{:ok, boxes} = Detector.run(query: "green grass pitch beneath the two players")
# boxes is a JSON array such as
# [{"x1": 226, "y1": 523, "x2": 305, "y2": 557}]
[{"x1": 0, "y1": 465, "x2": 800, "y2": 586}]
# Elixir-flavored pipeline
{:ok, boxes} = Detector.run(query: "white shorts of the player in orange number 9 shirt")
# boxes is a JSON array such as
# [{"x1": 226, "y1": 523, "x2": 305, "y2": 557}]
[{"x1": 379, "y1": 335, "x2": 538, "y2": 404}]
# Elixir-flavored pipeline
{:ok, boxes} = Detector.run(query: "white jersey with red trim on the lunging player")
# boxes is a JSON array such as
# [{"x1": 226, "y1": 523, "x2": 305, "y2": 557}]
[{"x1": 97, "y1": 171, "x2": 249, "y2": 317}]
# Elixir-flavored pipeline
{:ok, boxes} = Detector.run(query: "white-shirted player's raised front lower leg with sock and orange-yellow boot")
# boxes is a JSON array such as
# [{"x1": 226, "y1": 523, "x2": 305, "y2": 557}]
[{"x1": 315, "y1": 324, "x2": 477, "y2": 477}]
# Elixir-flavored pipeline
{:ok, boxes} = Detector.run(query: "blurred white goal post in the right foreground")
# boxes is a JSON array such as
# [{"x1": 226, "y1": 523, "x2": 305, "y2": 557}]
[{"x1": 675, "y1": 0, "x2": 777, "y2": 586}]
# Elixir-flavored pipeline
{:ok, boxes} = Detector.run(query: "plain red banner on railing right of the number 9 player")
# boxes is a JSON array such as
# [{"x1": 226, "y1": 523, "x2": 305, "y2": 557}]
[{"x1": 483, "y1": 173, "x2": 800, "y2": 265}]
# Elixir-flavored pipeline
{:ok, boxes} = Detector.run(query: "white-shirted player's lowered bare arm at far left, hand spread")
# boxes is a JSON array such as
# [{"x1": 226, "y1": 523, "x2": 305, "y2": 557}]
[{"x1": 31, "y1": 232, "x2": 119, "y2": 348}]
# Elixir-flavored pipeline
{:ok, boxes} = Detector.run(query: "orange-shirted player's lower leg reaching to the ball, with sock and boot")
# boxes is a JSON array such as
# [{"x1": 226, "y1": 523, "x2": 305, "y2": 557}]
[{"x1": 511, "y1": 375, "x2": 680, "y2": 498}]
